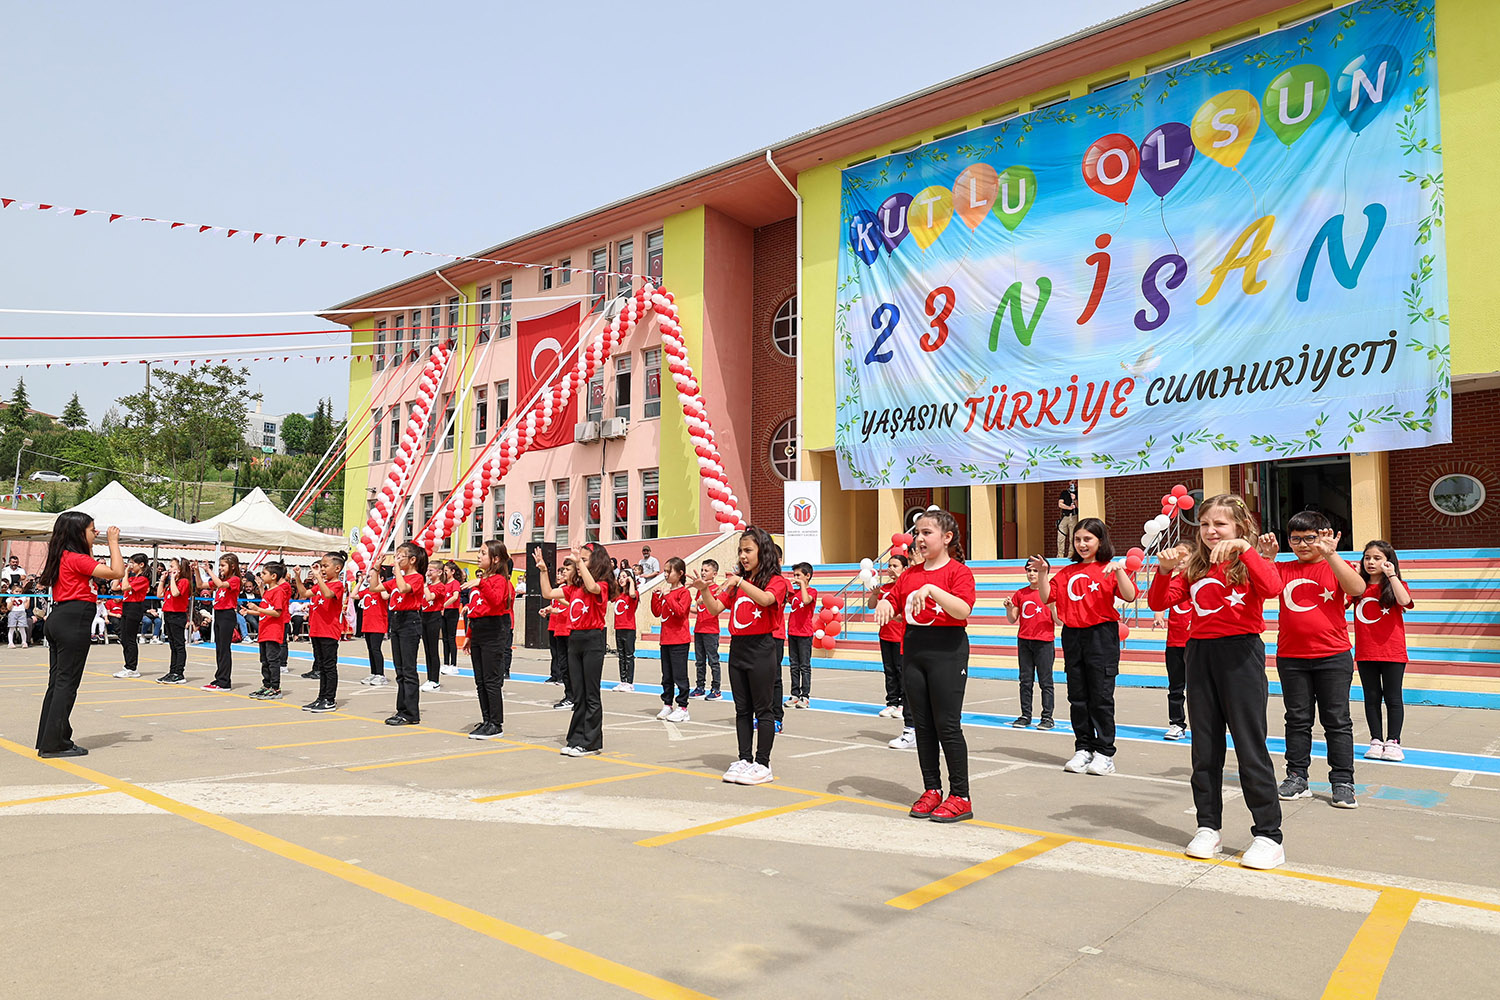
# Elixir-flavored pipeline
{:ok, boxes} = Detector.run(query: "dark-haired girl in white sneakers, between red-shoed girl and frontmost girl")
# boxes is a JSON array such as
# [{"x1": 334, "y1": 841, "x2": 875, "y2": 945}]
[{"x1": 1028, "y1": 517, "x2": 1136, "y2": 775}]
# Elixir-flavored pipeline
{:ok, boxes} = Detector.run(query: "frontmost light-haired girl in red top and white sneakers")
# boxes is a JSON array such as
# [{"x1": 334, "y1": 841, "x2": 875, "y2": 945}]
[{"x1": 1146, "y1": 493, "x2": 1287, "y2": 868}]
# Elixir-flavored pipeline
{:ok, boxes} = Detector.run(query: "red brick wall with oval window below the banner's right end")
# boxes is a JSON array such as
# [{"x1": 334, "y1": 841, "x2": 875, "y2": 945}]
[{"x1": 1380, "y1": 388, "x2": 1500, "y2": 549}]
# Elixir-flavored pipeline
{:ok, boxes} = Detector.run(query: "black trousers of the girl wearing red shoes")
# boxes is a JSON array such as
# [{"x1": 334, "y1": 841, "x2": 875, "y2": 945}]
[{"x1": 902, "y1": 624, "x2": 969, "y2": 799}]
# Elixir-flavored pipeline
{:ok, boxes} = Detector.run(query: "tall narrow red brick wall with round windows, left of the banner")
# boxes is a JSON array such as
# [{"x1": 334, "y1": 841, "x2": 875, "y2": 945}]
[{"x1": 749, "y1": 219, "x2": 797, "y2": 532}]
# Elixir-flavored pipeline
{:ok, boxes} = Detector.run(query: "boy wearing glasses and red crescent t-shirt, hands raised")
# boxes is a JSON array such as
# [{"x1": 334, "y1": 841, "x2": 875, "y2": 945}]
[{"x1": 1256, "y1": 510, "x2": 1365, "y2": 810}]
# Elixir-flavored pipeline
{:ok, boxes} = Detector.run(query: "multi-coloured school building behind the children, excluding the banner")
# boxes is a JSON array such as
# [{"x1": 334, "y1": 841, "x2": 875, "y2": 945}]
[{"x1": 329, "y1": 0, "x2": 1500, "y2": 562}]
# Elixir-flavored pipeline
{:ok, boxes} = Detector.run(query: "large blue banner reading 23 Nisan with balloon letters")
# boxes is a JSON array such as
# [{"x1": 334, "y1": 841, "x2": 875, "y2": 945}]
[{"x1": 834, "y1": 0, "x2": 1452, "y2": 487}]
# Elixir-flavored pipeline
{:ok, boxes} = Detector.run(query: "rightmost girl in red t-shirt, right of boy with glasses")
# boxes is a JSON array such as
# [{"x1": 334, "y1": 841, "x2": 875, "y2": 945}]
[{"x1": 1349, "y1": 541, "x2": 1413, "y2": 760}]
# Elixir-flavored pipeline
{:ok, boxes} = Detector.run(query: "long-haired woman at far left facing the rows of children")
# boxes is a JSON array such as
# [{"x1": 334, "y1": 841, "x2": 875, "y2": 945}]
[{"x1": 36, "y1": 511, "x2": 125, "y2": 757}]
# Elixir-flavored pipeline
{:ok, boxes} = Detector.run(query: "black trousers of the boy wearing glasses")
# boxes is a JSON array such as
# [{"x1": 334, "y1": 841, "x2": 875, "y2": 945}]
[{"x1": 1277, "y1": 652, "x2": 1355, "y2": 784}]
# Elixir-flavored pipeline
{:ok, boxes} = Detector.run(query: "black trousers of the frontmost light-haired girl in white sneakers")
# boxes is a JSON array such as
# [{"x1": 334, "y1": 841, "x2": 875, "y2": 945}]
[{"x1": 1187, "y1": 636, "x2": 1281, "y2": 844}]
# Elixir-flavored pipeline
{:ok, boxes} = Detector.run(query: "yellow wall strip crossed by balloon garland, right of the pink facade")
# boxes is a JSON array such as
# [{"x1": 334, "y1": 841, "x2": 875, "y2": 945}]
[{"x1": 657, "y1": 205, "x2": 707, "y2": 537}]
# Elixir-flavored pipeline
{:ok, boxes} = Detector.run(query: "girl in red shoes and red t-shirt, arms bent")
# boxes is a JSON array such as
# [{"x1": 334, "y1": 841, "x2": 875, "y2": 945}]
[{"x1": 875, "y1": 508, "x2": 975, "y2": 823}]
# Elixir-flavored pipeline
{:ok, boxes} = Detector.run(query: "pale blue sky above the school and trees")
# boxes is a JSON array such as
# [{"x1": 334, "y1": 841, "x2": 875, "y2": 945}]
[{"x1": 0, "y1": 0, "x2": 1139, "y2": 420}]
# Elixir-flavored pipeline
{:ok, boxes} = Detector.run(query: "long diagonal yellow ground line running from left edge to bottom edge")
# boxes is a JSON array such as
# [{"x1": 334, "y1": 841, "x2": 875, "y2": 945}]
[{"x1": 0, "y1": 739, "x2": 713, "y2": 1000}]
